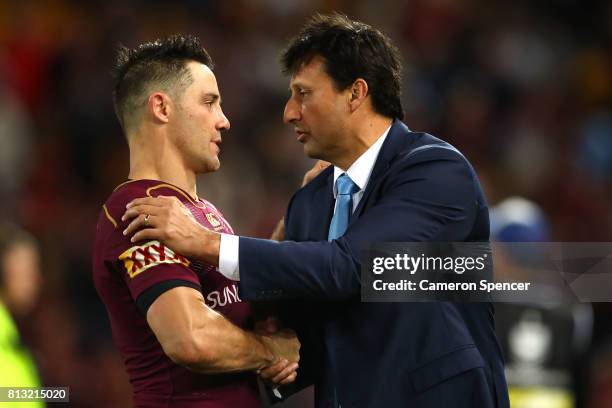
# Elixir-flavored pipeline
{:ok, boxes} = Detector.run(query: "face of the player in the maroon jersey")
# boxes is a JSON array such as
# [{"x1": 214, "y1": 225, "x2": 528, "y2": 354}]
[{"x1": 172, "y1": 61, "x2": 230, "y2": 173}]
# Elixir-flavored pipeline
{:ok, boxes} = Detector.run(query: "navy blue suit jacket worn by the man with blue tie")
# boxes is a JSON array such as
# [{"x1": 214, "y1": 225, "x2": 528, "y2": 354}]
[{"x1": 240, "y1": 121, "x2": 509, "y2": 408}]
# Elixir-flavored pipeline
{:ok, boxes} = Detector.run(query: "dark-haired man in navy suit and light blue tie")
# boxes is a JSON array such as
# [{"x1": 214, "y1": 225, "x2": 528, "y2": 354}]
[{"x1": 126, "y1": 14, "x2": 509, "y2": 408}]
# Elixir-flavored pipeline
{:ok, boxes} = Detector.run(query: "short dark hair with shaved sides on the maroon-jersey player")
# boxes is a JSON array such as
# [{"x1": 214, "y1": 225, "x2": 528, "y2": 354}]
[{"x1": 113, "y1": 34, "x2": 213, "y2": 132}]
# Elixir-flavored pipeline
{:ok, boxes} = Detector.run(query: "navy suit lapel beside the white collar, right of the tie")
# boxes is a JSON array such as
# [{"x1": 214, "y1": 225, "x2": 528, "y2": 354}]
[{"x1": 351, "y1": 119, "x2": 413, "y2": 223}]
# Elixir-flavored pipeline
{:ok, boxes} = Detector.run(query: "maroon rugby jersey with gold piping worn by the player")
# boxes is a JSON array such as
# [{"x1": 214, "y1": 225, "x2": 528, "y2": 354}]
[{"x1": 93, "y1": 180, "x2": 260, "y2": 408}]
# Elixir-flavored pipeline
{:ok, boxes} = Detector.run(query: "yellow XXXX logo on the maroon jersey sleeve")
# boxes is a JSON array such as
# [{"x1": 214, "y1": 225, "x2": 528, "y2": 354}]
[{"x1": 119, "y1": 241, "x2": 189, "y2": 278}]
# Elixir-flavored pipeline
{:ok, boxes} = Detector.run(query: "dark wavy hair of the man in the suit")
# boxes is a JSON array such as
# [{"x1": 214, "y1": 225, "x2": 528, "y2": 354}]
[{"x1": 281, "y1": 13, "x2": 404, "y2": 119}]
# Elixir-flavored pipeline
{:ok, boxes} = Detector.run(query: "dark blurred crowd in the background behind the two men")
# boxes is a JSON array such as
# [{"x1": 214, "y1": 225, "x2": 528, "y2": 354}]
[{"x1": 0, "y1": 0, "x2": 612, "y2": 408}]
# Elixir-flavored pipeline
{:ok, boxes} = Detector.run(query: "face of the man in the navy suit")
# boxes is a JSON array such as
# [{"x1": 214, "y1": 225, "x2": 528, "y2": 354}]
[{"x1": 283, "y1": 56, "x2": 350, "y2": 163}]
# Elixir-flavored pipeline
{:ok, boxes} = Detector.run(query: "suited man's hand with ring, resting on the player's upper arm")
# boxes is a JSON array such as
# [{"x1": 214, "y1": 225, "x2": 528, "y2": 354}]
[{"x1": 121, "y1": 196, "x2": 221, "y2": 265}]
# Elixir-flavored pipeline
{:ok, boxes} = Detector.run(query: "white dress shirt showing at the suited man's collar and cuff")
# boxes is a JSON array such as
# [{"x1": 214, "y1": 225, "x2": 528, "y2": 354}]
[{"x1": 219, "y1": 126, "x2": 391, "y2": 281}]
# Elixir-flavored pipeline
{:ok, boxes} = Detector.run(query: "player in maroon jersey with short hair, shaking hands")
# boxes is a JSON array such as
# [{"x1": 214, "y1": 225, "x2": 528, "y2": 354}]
[{"x1": 93, "y1": 36, "x2": 299, "y2": 408}]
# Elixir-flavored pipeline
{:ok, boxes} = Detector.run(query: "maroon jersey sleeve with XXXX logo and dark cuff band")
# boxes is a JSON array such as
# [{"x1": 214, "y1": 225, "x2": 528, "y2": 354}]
[{"x1": 104, "y1": 183, "x2": 201, "y2": 313}]
